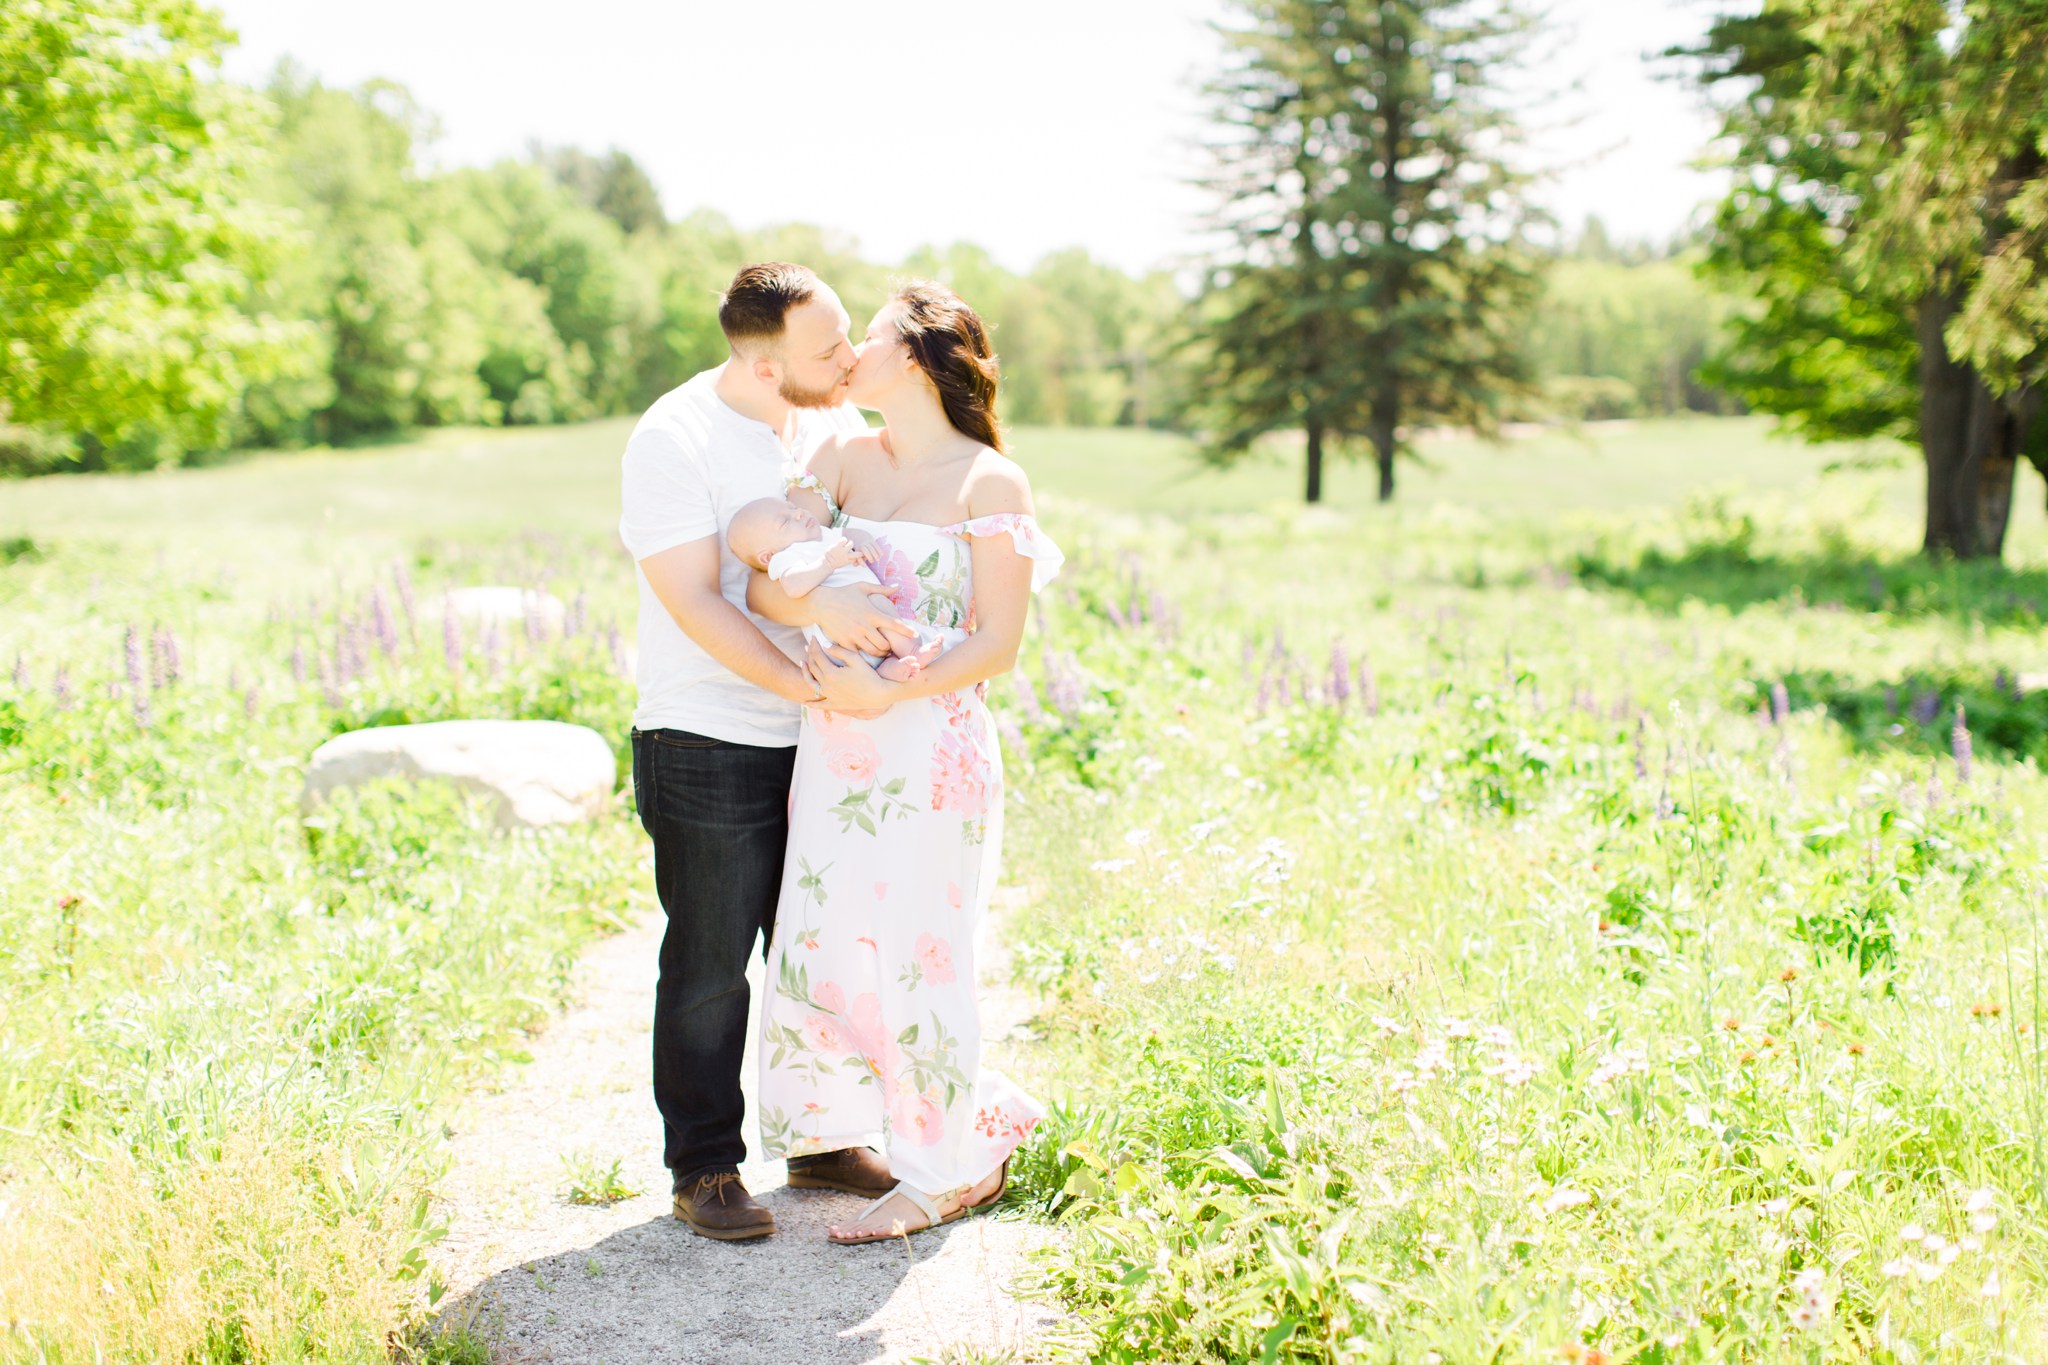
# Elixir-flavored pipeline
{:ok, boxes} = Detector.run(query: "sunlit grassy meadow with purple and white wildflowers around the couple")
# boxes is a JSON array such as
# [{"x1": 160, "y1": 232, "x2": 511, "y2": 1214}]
[{"x1": 0, "y1": 422, "x2": 2048, "y2": 1363}]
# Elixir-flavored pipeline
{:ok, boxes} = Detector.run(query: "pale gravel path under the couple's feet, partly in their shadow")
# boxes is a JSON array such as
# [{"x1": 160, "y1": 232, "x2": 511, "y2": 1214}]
[{"x1": 434, "y1": 892, "x2": 1059, "y2": 1365}]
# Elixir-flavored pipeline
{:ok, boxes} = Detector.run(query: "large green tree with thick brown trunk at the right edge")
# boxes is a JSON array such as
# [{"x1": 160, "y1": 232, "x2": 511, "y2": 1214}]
[{"x1": 1681, "y1": 0, "x2": 2048, "y2": 559}]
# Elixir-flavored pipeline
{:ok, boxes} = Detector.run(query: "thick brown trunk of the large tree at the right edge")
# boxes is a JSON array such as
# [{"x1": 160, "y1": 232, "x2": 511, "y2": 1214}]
[{"x1": 1915, "y1": 291, "x2": 2036, "y2": 559}]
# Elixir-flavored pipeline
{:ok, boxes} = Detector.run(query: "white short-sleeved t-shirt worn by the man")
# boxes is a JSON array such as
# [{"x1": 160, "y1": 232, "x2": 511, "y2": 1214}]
[{"x1": 618, "y1": 366, "x2": 868, "y2": 747}]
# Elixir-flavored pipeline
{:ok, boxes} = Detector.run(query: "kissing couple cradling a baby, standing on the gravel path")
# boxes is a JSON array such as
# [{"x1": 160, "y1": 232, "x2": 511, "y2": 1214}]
[{"x1": 618, "y1": 262, "x2": 1061, "y2": 1244}]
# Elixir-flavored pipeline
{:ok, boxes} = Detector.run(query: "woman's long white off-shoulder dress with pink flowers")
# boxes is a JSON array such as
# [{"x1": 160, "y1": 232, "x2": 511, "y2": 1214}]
[{"x1": 760, "y1": 514, "x2": 1061, "y2": 1193}]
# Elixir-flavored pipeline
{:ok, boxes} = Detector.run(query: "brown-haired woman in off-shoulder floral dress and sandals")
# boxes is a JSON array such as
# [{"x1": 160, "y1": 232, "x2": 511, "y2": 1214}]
[{"x1": 760, "y1": 284, "x2": 1061, "y2": 1244}]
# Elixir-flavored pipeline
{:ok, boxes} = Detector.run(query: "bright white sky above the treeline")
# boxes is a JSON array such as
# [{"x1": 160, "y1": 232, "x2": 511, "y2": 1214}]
[{"x1": 215, "y1": 0, "x2": 1720, "y2": 270}]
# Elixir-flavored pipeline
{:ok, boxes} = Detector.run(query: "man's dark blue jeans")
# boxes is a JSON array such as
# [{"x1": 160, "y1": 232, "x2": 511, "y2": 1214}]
[{"x1": 633, "y1": 731, "x2": 797, "y2": 1183}]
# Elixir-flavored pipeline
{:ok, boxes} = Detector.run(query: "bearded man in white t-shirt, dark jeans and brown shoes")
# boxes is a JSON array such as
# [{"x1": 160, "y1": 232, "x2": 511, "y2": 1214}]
[{"x1": 618, "y1": 262, "x2": 903, "y2": 1240}]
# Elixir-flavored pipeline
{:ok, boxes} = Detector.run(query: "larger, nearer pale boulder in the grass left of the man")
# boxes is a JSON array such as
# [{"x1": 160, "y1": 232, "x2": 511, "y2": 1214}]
[{"x1": 299, "y1": 720, "x2": 618, "y2": 829}]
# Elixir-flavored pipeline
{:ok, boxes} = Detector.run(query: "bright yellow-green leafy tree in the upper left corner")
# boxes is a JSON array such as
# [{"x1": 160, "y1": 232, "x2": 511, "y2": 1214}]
[{"x1": 0, "y1": 0, "x2": 311, "y2": 473}]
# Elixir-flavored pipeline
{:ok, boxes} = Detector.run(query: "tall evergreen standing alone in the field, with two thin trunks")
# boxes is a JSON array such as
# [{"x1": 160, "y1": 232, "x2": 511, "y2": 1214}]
[{"x1": 1200, "y1": 0, "x2": 1536, "y2": 501}]
